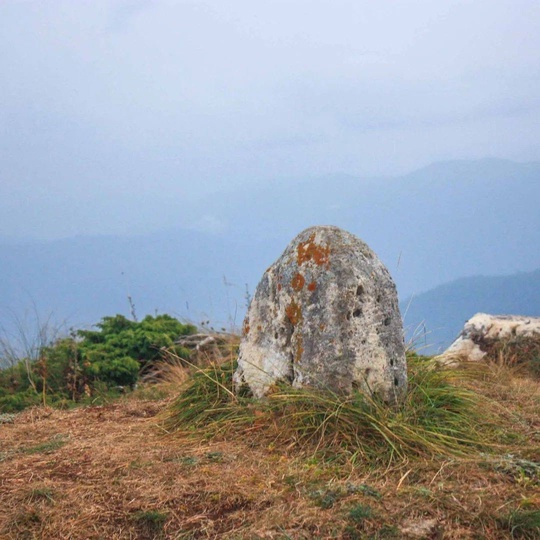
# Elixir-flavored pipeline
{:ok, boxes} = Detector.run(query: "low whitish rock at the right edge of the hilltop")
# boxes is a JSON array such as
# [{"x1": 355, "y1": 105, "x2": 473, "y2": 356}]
[{"x1": 438, "y1": 313, "x2": 540, "y2": 362}]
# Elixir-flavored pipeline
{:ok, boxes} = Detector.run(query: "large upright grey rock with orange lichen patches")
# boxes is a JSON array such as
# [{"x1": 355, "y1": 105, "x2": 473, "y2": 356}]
[{"x1": 234, "y1": 227, "x2": 407, "y2": 402}]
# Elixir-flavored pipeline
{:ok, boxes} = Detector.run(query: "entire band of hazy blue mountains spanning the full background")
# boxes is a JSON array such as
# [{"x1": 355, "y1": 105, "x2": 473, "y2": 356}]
[{"x1": 0, "y1": 160, "x2": 540, "y2": 346}]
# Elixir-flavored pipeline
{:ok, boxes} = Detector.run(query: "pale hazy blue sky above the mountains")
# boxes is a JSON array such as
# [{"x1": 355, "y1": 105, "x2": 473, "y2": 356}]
[{"x1": 0, "y1": 0, "x2": 540, "y2": 238}]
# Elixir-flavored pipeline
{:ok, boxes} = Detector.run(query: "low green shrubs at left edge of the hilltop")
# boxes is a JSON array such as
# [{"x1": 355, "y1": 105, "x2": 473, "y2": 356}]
[{"x1": 0, "y1": 315, "x2": 196, "y2": 412}]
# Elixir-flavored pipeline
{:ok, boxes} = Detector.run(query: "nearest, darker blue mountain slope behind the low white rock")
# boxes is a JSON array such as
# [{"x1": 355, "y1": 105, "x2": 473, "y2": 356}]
[{"x1": 400, "y1": 269, "x2": 540, "y2": 354}]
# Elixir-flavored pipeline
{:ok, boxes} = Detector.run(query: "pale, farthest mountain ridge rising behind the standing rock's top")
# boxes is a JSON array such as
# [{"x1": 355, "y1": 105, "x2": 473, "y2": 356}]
[{"x1": 177, "y1": 159, "x2": 540, "y2": 298}]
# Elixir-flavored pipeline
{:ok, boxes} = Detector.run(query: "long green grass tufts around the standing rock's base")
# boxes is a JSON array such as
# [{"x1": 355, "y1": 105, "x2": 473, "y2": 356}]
[{"x1": 159, "y1": 355, "x2": 502, "y2": 462}]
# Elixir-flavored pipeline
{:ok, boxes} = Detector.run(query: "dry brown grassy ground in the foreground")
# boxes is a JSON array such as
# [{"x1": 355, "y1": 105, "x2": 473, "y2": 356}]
[{"x1": 0, "y1": 356, "x2": 540, "y2": 540}]
